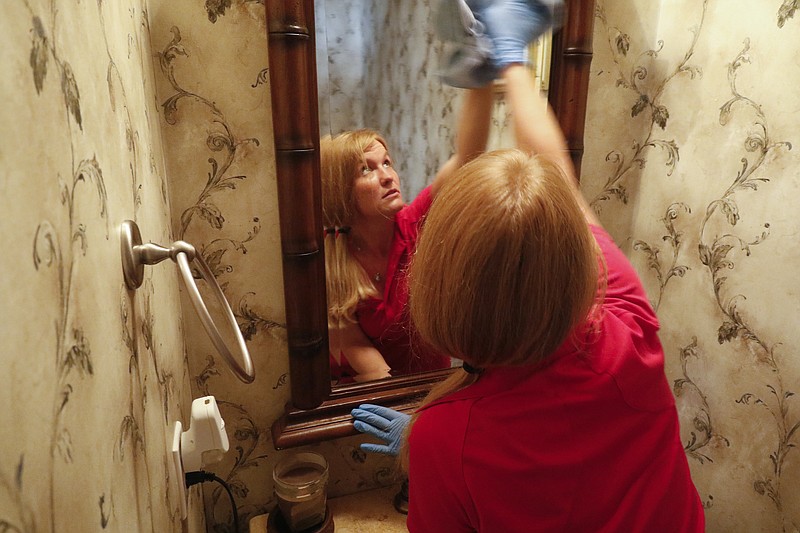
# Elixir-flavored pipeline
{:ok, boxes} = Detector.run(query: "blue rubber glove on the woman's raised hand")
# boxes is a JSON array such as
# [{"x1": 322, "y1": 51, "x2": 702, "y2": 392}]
[{"x1": 467, "y1": 0, "x2": 553, "y2": 69}]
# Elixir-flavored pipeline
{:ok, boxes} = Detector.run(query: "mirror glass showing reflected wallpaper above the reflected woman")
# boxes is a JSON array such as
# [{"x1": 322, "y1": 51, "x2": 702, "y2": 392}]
[{"x1": 314, "y1": 0, "x2": 551, "y2": 384}]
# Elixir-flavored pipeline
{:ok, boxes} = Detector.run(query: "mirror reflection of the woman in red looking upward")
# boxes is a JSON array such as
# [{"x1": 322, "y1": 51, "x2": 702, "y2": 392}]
[{"x1": 320, "y1": 87, "x2": 493, "y2": 381}]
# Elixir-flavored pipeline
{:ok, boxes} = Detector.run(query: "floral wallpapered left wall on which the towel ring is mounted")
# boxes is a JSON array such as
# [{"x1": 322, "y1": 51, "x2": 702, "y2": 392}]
[{"x1": 0, "y1": 0, "x2": 205, "y2": 533}]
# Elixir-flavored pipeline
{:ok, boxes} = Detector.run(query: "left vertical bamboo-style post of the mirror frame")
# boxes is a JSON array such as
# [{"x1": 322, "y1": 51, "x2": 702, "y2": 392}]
[{"x1": 266, "y1": 0, "x2": 330, "y2": 409}]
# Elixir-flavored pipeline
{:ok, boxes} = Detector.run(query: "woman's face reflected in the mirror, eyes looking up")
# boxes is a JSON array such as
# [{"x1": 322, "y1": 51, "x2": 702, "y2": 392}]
[{"x1": 353, "y1": 141, "x2": 404, "y2": 218}]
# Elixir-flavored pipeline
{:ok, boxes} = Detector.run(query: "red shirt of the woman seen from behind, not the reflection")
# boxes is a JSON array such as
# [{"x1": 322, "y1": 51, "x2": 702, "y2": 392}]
[{"x1": 408, "y1": 227, "x2": 704, "y2": 533}]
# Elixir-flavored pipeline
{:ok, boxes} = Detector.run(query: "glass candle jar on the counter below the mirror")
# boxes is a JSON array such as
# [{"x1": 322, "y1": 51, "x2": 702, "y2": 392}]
[{"x1": 272, "y1": 452, "x2": 328, "y2": 532}]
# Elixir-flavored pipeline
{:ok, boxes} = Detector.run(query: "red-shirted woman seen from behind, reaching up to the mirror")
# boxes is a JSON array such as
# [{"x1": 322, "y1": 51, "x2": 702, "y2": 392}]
[{"x1": 353, "y1": 1, "x2": 705, "y2": 533}]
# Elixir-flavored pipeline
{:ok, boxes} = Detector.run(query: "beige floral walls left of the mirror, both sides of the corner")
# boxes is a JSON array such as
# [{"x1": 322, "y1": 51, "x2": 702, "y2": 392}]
[{"x1": 0, "y1": 0, "x2": 392, "y2": 531}]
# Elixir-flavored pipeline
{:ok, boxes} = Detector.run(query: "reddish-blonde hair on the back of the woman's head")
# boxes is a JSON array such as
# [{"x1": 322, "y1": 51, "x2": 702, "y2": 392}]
[{"x1": 400, "y1": 150, "x2": 600, "y2": 467}]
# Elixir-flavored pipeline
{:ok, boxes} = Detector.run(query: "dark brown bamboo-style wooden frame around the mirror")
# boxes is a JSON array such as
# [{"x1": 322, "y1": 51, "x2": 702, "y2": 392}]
[{"x1": 265, "y1": 0, "x2": 594, "y2": 449}]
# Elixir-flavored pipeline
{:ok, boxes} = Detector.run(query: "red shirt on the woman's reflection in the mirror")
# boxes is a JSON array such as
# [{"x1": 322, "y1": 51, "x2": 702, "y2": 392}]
[{"x1": 356, "y1": 187, "x2": 450, "y2": 374}]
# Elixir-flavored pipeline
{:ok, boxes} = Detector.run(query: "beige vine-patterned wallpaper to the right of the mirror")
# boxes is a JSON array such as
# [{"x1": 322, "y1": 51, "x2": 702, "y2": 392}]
[{"x1": 582, "y1": 0, "x2": 800, "y2": 532}]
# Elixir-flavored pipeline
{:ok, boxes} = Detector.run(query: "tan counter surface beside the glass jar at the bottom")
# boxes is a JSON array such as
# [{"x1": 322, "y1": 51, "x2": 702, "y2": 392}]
[{"x1": 250, "y1": 485, "x2": 408, "y2": 533}]
